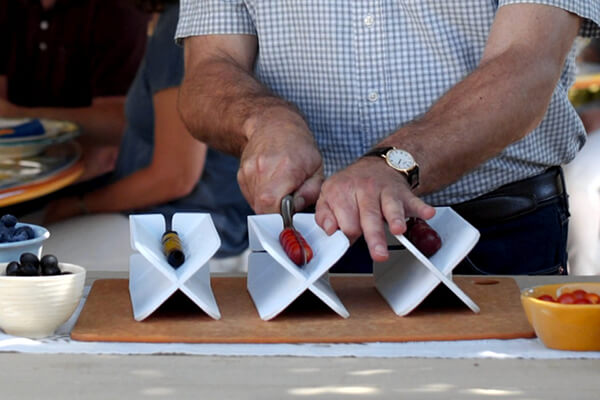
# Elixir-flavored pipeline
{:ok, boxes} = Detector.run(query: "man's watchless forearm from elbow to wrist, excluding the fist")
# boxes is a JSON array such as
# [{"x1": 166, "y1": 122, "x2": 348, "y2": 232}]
[{"x1": 179, "y1": 50, "x2": 305, "y2": 156}]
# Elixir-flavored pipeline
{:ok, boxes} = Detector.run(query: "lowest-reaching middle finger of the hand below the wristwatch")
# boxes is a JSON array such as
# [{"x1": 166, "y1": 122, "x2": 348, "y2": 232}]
[{"x1": 357, "y1": 190, "x2": 389, "y2": 262}]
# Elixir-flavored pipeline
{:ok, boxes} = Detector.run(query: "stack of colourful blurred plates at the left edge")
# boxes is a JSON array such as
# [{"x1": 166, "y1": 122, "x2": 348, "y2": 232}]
[{"x1": 0, "y1": 118, "x2": 83, "y2": 206}]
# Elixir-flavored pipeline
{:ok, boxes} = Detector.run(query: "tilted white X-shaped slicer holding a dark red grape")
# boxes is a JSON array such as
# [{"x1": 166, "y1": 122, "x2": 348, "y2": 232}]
[{"x1": 373, "y1": 207, "x2": 480, "y2": 316}]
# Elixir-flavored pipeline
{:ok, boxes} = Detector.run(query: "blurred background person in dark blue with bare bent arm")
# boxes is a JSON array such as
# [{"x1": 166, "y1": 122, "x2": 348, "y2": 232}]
[{"x1": 45, "y1": 0, "x2": 252, "y2": 271}]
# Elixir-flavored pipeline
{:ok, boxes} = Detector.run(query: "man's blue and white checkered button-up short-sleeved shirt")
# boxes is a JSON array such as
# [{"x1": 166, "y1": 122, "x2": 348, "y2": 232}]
[{"x1": 176, "y1": 0, "x2": 600, "y2": 205}]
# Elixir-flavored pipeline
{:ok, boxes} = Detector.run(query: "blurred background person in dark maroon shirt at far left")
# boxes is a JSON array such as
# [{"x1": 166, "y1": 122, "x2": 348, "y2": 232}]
[{"x1": 0, "y1": 0, "x2": 148, "y2": 215}]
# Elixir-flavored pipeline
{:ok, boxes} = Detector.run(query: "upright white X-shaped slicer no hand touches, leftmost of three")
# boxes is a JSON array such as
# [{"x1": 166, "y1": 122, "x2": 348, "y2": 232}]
[{"x1": 129, "y1": 213, "x2": 221, "y2": 321}]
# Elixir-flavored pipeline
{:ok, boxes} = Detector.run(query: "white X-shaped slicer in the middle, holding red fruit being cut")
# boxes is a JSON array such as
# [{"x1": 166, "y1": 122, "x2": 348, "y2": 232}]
[{"x1": 247, "y1": 213, "x2": 350, "y2": 320}]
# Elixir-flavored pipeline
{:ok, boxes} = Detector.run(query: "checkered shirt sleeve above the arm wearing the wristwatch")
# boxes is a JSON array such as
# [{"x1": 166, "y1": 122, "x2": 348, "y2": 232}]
[{"x1": 498, "y1": 0, "x2": 600, "y2": 37}]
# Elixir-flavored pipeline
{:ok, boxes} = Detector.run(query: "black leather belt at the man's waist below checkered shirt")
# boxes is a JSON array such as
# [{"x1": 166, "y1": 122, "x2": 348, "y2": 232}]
[{"x1": 451, "y1": 167, "x2": 565, "y2": 225}]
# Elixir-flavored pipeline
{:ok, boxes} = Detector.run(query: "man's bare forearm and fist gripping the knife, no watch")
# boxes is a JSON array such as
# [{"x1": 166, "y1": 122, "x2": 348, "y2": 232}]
[{"x1": 179, "y1": 35, "x2": 323, "y2": 214}]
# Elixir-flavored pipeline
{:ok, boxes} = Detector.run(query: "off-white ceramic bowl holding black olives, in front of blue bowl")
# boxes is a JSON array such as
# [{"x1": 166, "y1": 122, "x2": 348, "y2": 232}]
[{"x1": 0, "y1": 263, "x2": 86, "y2": 339}]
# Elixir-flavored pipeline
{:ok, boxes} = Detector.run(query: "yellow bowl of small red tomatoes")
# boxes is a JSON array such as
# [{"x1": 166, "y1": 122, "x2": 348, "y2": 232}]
[{"x1": 521, "y1": 282, "x2": 600, "y2": 351}]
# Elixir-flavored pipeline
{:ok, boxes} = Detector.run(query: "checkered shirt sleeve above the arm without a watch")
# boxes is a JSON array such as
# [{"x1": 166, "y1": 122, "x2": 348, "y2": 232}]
[{"x1": 175, "y1": 0, "x2": 256, "y2": 43}]
